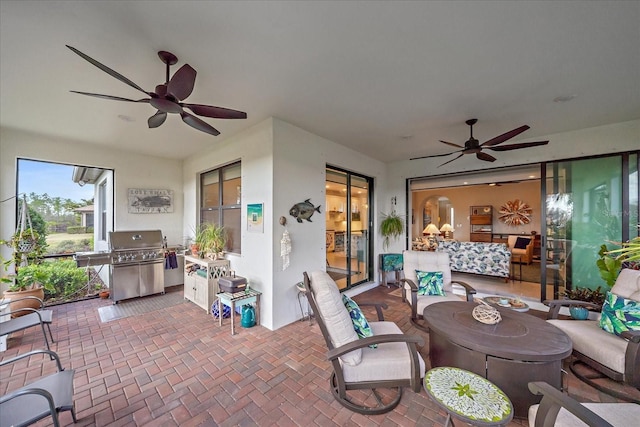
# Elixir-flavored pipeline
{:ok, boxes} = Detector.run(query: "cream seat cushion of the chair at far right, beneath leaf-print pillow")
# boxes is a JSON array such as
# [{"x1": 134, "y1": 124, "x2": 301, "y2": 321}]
[{"x1": 547, "y1": 319, "x2": 627, "y2": 373}]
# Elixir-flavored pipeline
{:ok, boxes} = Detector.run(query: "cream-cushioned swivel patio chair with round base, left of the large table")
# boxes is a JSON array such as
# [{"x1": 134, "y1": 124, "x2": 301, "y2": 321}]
[{"x1": 304, "y1": 271, "x2": 426, "y2": 415}]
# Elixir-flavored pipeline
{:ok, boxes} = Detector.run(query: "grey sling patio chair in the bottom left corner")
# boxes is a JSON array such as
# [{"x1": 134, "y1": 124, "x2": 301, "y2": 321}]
[{"x1": 0, "y1": 350, "x2": 78, "y2": 427}]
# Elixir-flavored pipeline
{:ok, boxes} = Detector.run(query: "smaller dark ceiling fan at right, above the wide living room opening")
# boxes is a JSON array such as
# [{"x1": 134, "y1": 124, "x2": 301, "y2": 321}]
[{"x1": 411, "y1": 119, "x2": 549, "y2": 167}]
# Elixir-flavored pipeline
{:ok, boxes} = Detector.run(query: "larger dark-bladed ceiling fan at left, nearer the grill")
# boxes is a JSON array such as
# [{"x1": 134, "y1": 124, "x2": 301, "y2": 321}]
[{"x1": 66, "y1": 45, "x2": 247, "y2": 136}]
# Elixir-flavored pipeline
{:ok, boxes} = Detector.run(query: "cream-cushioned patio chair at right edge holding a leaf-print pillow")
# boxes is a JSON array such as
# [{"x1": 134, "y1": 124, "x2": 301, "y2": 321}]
[{"x1": 545, "y1": 268, "x2": 640, "y2": 403}]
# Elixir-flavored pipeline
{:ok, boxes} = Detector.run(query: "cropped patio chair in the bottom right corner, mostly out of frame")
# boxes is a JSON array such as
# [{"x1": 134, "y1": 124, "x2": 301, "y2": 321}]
[{"x1": 529, "y1": 382, "x2": 640, "y2": 427}]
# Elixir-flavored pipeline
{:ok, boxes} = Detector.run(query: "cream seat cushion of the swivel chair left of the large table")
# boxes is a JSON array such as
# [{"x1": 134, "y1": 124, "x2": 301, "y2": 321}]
[{"x1": 342, "y1": 322, "x2": 426, "y2": 383}]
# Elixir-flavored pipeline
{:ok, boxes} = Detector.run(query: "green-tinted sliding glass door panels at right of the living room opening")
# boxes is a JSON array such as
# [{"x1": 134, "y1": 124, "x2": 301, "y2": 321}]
[{"x1": 541, "y1": 154, "x2": 638, "y2": 300}]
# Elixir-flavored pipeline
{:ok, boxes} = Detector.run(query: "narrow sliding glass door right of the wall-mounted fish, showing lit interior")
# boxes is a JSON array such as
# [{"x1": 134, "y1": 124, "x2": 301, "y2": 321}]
[{"x1": 325, "y1": 167, "x2": 372, "y2": 290}]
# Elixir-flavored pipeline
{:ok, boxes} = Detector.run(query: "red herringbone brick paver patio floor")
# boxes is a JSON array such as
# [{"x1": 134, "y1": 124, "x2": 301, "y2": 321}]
[{"x1": 0, "y1": 287, "x2": 636, "y2": 427}]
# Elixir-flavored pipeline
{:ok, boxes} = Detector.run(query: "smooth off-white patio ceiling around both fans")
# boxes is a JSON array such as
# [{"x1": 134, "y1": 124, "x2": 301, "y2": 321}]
[{"x1": 0, "y1": 1, "x2": 640, "y2": 162}]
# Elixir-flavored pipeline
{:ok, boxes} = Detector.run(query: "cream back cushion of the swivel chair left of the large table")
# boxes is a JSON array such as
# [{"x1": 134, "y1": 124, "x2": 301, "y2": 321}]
[{"x1": 310, "y1": 271, "x2": 362, "y2": 365}]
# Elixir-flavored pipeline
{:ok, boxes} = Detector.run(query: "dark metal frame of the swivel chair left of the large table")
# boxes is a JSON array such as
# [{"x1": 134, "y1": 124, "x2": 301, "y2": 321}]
[{"x1": 304, "y1": 272, "x2": 424, "y2": 415}]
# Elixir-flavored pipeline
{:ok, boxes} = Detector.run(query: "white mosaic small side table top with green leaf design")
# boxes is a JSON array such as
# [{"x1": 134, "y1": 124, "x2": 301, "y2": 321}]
[{"x1": 424, "y1": 366, "x2": 513, "y2": 425}]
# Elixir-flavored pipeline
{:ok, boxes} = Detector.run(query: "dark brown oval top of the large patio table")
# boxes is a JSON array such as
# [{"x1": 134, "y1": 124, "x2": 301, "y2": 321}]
[{"x1": 423, "y1": 301, "x2": 572, "y2": 362}]
